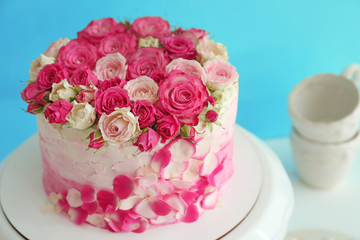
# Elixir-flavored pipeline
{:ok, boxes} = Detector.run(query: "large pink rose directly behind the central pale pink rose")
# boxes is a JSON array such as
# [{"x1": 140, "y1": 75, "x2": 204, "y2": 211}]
[{"x1": 127, "y1": 47, "x2": 169, "y2": 80}]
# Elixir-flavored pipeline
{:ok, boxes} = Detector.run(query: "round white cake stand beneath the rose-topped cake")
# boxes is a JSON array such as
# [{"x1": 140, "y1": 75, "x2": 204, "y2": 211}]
[{"x1": 0, "y1": 126, "x2": 293, "y2": 240}]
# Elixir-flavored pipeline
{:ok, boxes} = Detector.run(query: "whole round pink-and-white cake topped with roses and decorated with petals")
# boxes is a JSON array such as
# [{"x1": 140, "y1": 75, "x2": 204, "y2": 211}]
[{"x1": 21, "y1": 17, "x2": 238, "y2": 233}]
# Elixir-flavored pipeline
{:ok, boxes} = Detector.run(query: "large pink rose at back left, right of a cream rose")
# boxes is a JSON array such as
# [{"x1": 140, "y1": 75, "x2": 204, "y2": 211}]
[{"x1": 57, "y1": 39, "x2": 98, "y2": 72}]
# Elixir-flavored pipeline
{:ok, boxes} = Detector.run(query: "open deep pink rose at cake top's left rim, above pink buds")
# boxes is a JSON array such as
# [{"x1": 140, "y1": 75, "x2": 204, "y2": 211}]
[{"x1": 36, "y1": 63, "x2": 69, "y2": 90}]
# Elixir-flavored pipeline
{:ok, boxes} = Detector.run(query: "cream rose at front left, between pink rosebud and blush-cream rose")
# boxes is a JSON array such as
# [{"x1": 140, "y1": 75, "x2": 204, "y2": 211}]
[{"x1": 66, "y1": 101, "x2": 96, "y2": 129}]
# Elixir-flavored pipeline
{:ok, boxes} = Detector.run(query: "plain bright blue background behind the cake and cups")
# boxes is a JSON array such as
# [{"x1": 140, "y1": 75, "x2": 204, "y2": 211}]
[{"x1": 0, "y1": 0, "x2": 360, "y2": 160}]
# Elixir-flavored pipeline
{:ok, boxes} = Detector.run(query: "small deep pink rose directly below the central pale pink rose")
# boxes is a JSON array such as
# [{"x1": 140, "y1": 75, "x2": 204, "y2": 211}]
[{"x1": 131, "y1": 100, "x2": 156, "y2": 128}]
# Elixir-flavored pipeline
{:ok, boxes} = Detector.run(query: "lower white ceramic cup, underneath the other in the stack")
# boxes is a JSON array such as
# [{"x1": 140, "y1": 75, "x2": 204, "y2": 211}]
[{"x1": 291, "y1": 128, "x2": 360, "y2": 188}]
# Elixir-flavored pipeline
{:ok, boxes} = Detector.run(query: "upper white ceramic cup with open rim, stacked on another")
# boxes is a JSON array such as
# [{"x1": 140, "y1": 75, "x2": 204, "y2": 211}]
[{"x1": 288, "y1": 64, "x2": 360, "y2": 143}]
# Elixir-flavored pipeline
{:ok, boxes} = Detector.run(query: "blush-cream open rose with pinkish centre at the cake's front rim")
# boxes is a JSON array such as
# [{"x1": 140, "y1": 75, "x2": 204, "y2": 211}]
[{"x1": 99, "y1": 108, "x2": 139, "y2": 143}]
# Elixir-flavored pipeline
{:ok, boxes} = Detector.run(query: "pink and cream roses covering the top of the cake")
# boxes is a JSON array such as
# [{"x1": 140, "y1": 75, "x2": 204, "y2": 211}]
[{"x1": 21, "y1": 17, "x2": 238, "y2": 151}]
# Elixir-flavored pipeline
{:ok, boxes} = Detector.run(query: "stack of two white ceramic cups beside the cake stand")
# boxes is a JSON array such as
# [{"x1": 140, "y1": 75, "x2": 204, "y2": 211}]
[{"x1": 288, "y1": 65, "x2": 360, "y2": 188}]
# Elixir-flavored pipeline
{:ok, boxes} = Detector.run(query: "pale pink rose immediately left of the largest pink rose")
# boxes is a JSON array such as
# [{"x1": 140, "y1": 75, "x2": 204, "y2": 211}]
[{"x1": 124, "y1": 76, "x2": 159, "y2": 103}]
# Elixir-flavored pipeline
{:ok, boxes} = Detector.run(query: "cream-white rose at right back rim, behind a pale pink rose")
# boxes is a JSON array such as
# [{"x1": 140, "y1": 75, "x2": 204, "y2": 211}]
[{"x1": 196, "y1": 38, "x2": 229, "y2": 62}]
